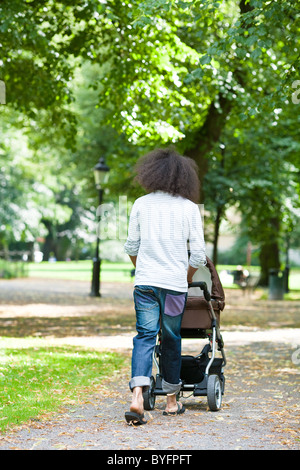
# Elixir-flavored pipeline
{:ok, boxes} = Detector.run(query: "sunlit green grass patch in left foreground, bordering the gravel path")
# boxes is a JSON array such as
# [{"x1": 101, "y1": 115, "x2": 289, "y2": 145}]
[{"x1": 0, "y1": 338, "x2": 126, "y2": 432}]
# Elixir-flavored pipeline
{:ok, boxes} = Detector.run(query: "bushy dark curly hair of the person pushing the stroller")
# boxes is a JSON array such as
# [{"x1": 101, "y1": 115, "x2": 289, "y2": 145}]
[{"x1": 135, "y1": 148, "x2": 200, "y2": 203}]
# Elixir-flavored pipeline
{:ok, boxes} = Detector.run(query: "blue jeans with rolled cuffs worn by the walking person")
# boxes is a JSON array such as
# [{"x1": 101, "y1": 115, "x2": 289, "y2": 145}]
[{"x1": 129, "y1": 285, "x2": 187, "y2": 393}]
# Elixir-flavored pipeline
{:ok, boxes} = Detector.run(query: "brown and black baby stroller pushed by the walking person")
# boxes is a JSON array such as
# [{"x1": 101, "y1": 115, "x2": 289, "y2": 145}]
[{"x1": 143, "y1": 258, "x2": 226, "y2": 411}]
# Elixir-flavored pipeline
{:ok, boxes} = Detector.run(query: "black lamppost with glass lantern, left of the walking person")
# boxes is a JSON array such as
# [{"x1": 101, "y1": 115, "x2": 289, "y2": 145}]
[{"x1": 91, "y1": 157, "x2": 110, "y2": 297}]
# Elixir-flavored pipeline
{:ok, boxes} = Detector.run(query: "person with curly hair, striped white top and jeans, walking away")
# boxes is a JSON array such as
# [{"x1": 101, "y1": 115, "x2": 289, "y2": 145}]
[{"x1": 124, "y1": 148, "x2": 206, "y2": 424}]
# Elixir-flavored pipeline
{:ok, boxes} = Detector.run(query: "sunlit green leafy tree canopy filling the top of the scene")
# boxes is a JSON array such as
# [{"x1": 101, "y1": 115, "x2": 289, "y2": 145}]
[{"x1": 0, "y1": 0, "x2": 300, "y2": 278}]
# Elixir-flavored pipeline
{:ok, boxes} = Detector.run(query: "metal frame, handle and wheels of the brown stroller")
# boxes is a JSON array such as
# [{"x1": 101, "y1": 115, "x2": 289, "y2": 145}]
[{"x1": 143, "y1": 281, "x2": 226, "y2": 411}]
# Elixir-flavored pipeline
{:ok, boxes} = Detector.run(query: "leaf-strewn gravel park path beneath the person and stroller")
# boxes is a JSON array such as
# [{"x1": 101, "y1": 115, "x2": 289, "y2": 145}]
[{"x1": 0, "y1": 279, "x2": 300, "y2": 452}]
